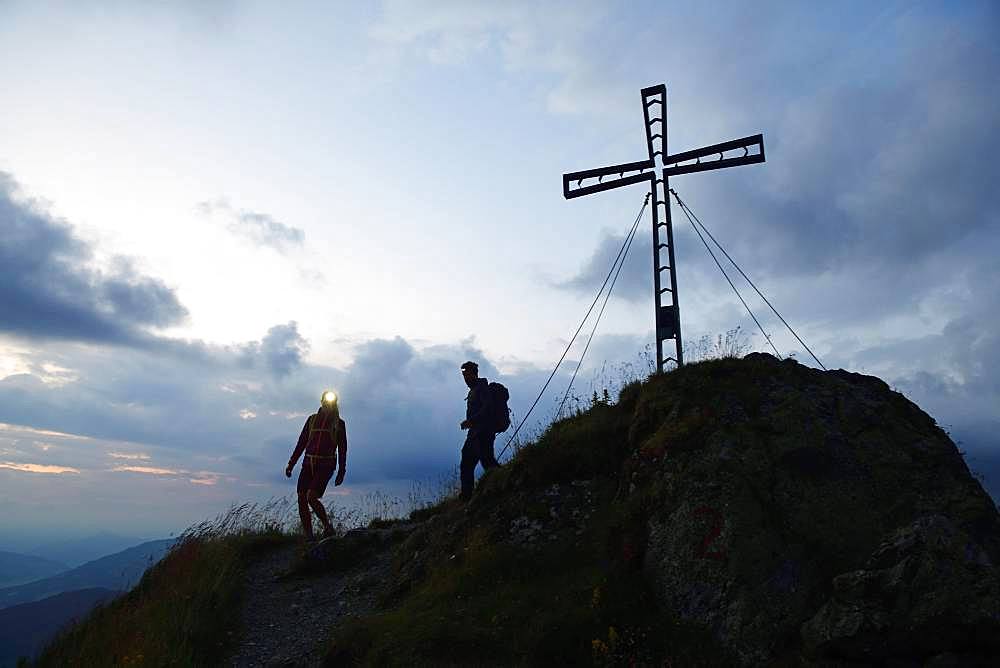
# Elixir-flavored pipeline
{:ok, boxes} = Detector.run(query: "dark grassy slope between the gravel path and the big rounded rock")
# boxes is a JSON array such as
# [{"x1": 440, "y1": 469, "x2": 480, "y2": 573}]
[{"x1": 318, "y1": 360, "x2": 752, "y2": 666}]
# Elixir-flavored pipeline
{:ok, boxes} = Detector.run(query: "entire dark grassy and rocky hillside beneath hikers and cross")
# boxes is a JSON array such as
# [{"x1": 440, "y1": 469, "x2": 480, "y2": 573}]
[{"x1": 42, "y1": 353, "x2": 1000, "y2": 667}]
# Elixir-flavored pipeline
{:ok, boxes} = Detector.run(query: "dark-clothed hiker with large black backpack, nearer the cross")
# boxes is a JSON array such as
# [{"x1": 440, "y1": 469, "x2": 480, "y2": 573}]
[{"x1": 459, "y1": 362, "x2": 510, "y2": 501}]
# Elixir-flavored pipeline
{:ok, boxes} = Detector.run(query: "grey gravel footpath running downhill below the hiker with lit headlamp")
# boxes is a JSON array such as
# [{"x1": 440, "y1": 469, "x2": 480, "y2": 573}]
[{"x1": 229, "y1": 545, "x2": 392, "y2": 666}]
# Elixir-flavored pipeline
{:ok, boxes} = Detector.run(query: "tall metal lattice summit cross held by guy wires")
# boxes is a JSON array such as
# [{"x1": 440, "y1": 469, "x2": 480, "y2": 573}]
[{"x1": 563, "y1": 84, "x2": 764, "y2": 371}]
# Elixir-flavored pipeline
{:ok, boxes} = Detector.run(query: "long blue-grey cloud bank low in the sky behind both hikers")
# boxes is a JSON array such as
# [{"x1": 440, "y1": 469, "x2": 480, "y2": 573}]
[{"x1": 0, "y1": 323, "x2": 616, "y2": 484}]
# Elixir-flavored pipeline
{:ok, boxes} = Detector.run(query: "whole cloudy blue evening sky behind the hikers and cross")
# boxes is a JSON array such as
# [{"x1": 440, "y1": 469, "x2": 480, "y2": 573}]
[{"x1": 0, "y1": 0, "x2": 1000, "y2": 548}]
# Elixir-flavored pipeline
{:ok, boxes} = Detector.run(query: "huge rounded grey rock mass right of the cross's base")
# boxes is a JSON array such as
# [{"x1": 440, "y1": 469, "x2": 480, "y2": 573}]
[{"x1": 620, "y1": 353, "x2": 1000, "y2": 665}]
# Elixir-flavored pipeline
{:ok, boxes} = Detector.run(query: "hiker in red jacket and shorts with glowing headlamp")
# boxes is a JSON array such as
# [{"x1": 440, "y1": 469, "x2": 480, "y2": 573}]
[{"x1": 285, "y1": 390, "x2": 347, "y2": 541}]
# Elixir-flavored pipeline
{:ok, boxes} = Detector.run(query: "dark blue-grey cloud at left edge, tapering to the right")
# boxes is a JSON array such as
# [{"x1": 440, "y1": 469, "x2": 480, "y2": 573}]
[{"x1": 0, "y1": 172, "x2": 187, "y2": 344}]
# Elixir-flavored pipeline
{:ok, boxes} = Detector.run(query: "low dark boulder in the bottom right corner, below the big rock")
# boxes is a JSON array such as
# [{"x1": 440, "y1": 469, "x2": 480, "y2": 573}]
[{"x1": 802, "y1": 515, "x2": 1000, "y2": 664}]
